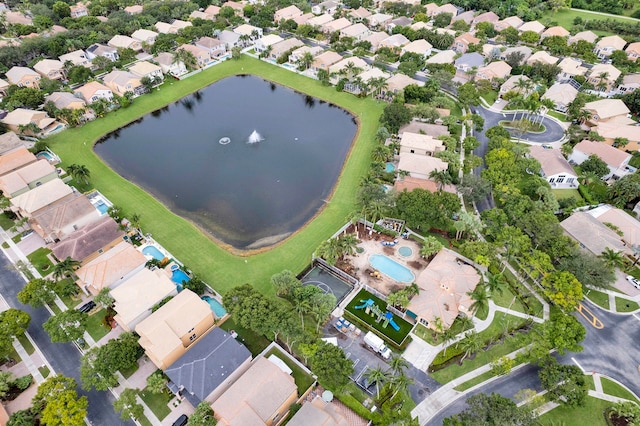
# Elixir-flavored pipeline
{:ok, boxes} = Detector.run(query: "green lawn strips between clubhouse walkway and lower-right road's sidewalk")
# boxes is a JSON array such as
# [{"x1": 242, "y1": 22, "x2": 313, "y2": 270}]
[{"x1": 431, "y1": 312, "x2": 529, "y2": 384}]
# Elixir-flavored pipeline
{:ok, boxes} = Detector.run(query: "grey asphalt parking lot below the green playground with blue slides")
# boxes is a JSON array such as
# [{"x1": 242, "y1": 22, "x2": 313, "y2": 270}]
[{"x1": 324, "y1": 319, "x2": 441, "y2": 404}]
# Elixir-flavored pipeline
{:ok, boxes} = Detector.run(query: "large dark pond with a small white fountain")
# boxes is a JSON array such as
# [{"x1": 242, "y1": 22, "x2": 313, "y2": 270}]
[{"x1": 95, "y1": 76, "x2": 357, "y2": 248}]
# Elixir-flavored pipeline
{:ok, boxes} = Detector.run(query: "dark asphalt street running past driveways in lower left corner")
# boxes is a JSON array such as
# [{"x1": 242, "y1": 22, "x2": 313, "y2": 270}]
[{"x1": 0, "y1": 251, "x2": 133, "y2": 426}]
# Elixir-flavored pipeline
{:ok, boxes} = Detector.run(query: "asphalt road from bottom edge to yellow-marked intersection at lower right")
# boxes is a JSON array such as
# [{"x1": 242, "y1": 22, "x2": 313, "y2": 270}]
[{"x1": 428, "y1": 301, "x2": 640, "y2": 425}]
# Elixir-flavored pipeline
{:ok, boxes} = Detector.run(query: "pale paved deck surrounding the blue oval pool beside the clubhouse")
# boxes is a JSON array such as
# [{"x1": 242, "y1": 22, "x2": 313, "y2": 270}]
[{"x1": 347, "y1": 233, "x2": 428, "y2": 295}]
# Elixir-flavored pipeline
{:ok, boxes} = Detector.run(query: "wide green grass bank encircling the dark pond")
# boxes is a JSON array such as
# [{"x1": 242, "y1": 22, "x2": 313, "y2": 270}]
[{"x1": 47, "y1": 57, "x2": 384, "y2": 294}]
